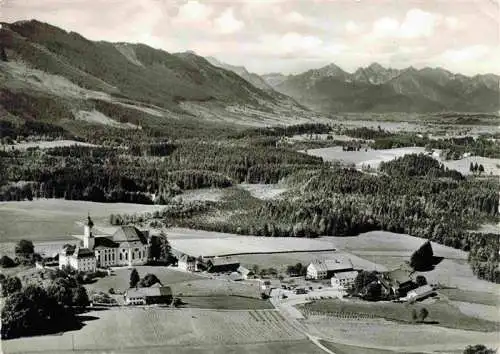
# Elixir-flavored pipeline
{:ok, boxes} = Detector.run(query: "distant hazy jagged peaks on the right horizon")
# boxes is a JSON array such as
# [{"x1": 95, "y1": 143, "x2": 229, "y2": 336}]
[{"x1": 263, "y1": 63, "x2": 500, "y2": 113}]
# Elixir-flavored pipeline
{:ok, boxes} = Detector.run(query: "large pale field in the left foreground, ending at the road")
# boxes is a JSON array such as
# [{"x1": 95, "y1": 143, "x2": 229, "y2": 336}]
[{"x1": 2, "y1": 307, "x2": 315, "y2": 353}]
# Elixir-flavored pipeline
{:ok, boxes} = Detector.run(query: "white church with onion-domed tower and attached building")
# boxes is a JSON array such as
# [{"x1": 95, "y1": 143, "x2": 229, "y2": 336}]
[{"x1": 59, "y1": 216, "x2": 150, "y2": 272}]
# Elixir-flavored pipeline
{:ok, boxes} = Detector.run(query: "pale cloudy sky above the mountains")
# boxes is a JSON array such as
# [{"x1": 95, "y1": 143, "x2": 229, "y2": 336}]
[{"x1": 0, "y1": 0, "x2": 500, "y2": 75}]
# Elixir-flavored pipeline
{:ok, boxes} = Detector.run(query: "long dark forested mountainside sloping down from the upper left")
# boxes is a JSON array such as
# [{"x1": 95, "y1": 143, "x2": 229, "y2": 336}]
[{"x1": 0, "y1": 20, "x2": 310, "y2": 142}]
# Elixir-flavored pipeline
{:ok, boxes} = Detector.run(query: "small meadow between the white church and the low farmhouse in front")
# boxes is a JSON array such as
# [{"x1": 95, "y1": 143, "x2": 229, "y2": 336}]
[{"x1": 85, "y1": 266, "x2": 203, "y2": 292}]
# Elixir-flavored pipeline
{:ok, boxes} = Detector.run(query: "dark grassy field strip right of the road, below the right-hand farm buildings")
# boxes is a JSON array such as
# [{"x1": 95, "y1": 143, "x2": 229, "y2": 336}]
[{"x1": 299, "y1": 300, "x2": 500, "y2": 332}]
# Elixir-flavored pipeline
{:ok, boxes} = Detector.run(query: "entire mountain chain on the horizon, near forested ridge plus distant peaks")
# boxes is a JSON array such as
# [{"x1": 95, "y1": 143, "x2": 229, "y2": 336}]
[{"x1": 0, "y1": 20, "x2": 500, "y2": 138}]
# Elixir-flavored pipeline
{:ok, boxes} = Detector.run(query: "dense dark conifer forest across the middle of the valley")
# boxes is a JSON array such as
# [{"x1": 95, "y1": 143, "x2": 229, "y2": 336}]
[{"x1": 0, "y1": 124, "x2": 500, "y2": 281}]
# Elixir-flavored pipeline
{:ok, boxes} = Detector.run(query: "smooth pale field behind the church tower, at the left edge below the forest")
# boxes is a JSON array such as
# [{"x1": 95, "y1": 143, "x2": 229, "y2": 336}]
[{"x1": 0, "y1": 199, "x2": 161, "y2": 242}]
